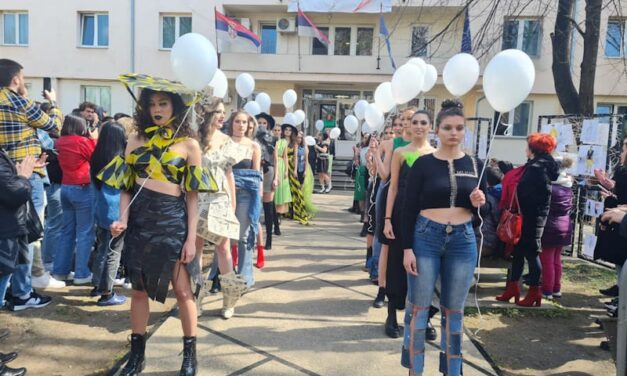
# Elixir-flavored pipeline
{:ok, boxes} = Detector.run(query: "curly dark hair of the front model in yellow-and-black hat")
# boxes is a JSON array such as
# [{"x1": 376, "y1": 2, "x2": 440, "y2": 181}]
[{"x1": 133, "y1": 89, "x2": 194, "y2": 138}]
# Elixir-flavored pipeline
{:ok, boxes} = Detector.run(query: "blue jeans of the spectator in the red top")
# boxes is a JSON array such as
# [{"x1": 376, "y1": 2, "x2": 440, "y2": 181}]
[{"x1": 53, "y1": 184, "x2": 95, "y2": 278}]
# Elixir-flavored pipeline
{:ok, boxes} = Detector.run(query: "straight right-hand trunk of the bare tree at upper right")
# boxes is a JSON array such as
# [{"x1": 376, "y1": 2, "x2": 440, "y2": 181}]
[{"x1": 579, "y1": 0, "x2": 603, "y2": 115}]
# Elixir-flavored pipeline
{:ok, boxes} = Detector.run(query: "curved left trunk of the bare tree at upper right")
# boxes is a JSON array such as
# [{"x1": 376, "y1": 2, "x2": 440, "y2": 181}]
[{"x1": 551, "y1": 0, "x2": 580, "y2": 114}]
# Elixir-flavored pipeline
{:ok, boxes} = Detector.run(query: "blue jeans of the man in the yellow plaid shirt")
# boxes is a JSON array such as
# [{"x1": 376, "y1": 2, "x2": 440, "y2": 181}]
[{"x1": 11, "y1": 173, "x2": 45, "y2": 297}]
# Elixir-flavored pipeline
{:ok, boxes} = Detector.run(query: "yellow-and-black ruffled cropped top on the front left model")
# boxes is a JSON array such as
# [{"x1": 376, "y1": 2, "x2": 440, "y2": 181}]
[{"x1": 96, "y1": 126, "x2": 218, "y2": 192}]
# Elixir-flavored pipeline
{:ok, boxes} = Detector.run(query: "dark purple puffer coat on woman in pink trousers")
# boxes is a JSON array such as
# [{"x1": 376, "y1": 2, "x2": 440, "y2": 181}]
[{"x1": 542, "y1": 172, "x2": 573, "y2": 248}]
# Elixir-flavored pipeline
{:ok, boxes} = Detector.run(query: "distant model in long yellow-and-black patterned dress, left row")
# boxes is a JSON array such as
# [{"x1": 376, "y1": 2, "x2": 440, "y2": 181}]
[{"x1": 281, "y1": 124, "x2": 309, "y2": 225}]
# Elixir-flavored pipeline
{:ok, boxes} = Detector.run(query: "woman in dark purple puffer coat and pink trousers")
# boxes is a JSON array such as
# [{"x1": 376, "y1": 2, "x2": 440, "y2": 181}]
[{"x1": 540, "y1": 158, "x2": 573, "y2": 299}]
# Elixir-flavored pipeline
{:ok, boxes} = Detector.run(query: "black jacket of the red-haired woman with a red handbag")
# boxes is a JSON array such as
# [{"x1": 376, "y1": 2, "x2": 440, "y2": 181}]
[{"x1": 516, "y1": 154, "x2": 559, "y2": 252}]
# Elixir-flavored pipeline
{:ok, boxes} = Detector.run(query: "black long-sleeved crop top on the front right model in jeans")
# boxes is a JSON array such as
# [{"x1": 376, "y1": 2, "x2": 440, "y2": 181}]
[{"x1": 401, "y1": 154, "x2": 486, "y2": 249}]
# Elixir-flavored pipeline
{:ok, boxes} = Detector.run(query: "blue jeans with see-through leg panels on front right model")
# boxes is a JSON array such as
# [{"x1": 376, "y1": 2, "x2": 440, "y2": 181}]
[{"x1": 401, "y1": 216, "x2": 477, "y2": 376}]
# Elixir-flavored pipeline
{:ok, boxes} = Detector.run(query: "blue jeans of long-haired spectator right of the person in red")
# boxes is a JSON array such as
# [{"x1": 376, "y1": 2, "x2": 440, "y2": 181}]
[{"x1": 91, "y1": 226, "x2": 124, "y2": 292}]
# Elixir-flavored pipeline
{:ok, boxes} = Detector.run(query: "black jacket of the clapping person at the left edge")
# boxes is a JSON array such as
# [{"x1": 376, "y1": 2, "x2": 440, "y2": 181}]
[{"x1": 0, "y1": 149, "x2": 31, "y2": 239}]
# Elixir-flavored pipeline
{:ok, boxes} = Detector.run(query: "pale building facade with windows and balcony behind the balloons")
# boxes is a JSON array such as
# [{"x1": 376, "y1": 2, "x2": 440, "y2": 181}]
[{"x1": 0, "y1": 0, "x2": 627, "y2": 163}]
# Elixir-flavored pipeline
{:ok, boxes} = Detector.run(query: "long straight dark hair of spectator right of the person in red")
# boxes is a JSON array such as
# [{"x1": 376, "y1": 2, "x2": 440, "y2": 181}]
[{"x1": 89, "y1": 121, "x2": 126, "y2": 189}]
